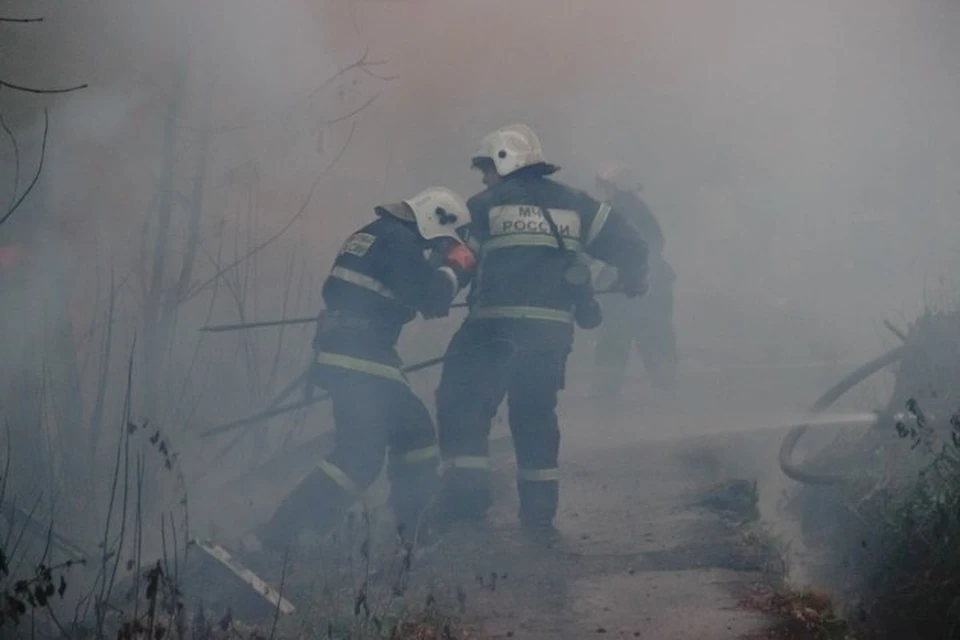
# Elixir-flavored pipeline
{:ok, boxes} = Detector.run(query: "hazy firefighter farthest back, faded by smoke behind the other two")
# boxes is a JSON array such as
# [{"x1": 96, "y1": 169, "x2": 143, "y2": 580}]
[{"x1": 595, "y1": 163, "x2": 677, "y2": 396}]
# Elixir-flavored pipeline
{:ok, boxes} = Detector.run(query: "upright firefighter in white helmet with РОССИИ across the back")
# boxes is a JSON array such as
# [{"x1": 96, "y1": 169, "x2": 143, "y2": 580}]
[{"x1": 433, "y1": 125, "x2": 647, "y2": 535}]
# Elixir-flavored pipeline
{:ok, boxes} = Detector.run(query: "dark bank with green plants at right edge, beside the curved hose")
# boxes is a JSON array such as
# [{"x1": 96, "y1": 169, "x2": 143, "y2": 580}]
[{"x1": 791, "y1": 311, "x2": 960, "y2": 640}]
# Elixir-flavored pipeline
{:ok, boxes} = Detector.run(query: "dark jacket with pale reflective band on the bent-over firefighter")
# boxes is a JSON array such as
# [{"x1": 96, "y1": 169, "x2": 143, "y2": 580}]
[{"x1": 314, "y1": 211, "x2": 458, "y2": 365}]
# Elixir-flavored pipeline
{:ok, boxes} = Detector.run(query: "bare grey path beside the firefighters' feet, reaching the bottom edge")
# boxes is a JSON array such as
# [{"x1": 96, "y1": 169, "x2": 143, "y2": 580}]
[{"x1": 414, "y1": 416, "x2": 796, "y2": 640}]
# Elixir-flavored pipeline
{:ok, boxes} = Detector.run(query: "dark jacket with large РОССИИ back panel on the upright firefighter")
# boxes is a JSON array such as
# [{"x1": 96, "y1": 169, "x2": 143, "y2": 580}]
[{"x1": 467, "y1": 170, "x2": 647, "y2": 339}]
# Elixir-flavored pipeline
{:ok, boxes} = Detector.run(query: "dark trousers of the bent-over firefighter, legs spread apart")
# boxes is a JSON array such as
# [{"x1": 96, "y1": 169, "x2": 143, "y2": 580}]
[{"x1": 260, "y1": 354, "x2": 438, "y2": 550}]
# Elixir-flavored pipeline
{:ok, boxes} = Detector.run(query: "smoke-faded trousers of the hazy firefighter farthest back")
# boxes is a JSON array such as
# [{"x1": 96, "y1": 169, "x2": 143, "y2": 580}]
[{"x1": 594, "y1": 283, "x2": 677, "y2": 395}]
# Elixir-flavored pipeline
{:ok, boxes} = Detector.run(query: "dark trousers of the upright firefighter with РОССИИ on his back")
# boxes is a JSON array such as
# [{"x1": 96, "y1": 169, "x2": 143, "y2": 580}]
[{"x1": 437, "y1": 320, "x2": 570, "y2": 527}]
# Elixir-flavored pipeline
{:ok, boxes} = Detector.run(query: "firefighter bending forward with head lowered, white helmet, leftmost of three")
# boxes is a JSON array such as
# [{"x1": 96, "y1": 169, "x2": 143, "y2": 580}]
[{"x1": 251, "y1": 188, "x2": 475, "y2": 552}]
